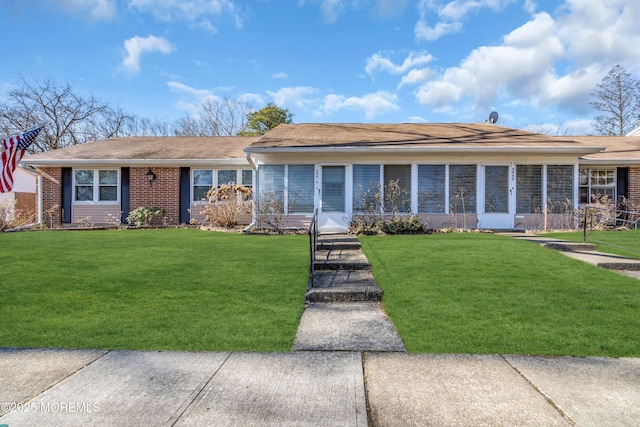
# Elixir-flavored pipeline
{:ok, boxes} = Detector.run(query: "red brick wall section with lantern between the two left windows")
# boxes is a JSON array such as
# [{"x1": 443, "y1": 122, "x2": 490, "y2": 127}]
[{"x1": 129, "y1": 167, "x2": 180, "y2": 224}]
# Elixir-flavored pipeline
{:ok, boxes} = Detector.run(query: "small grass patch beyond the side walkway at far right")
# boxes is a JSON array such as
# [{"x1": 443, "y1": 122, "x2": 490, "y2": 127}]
[{"x1": 540, "y1": 230, "x2": 640, "y2": 259}]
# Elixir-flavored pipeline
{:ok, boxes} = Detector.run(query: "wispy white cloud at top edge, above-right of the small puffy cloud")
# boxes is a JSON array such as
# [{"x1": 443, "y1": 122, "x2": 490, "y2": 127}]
[{"x1": 128, "y1": 0, "x2": 244, "y2": 29}]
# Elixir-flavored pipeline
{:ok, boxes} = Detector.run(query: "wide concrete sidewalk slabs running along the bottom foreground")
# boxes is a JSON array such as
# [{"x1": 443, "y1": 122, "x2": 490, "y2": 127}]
[{"x1": 0, "y1": 349, "x2": 640, "y2": 427}]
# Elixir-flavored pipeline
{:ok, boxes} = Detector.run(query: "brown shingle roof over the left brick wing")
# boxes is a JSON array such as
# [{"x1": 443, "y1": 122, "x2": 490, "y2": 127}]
[{"x1": 23, "y1": 137, "x2": 258, "y2": 165}]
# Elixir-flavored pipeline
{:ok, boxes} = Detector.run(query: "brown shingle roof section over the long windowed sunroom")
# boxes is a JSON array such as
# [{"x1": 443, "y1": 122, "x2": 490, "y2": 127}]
[{"x1": 247, "y1": 123, "x2": 597, "y2": 152}]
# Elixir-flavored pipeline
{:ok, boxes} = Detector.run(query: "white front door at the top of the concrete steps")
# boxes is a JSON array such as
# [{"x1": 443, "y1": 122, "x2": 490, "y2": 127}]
[{"x1": 318, "y1": 166, "x2": 348, "y2": 231}]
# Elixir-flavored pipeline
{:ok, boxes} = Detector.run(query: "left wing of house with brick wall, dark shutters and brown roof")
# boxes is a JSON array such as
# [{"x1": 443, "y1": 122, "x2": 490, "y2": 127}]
[{"x1": 22, "y1": 137, "x2": 257, "y2": 226}]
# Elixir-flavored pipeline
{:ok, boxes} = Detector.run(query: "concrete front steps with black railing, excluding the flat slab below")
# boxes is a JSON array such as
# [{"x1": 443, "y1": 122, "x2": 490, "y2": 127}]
[{"x1": 305, "y1": 234, "x2": 382, "y2": 303}]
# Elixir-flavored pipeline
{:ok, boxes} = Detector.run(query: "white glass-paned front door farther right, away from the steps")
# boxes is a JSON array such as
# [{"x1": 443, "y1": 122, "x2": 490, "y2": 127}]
[{"x1": 478, "y1": 165, "x2": 515, "y2": 229}]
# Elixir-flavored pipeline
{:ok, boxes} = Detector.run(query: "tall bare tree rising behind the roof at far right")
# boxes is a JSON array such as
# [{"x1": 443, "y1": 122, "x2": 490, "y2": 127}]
[{"x1": 589, "y1": 65, "x2": 640, "y2": 136}]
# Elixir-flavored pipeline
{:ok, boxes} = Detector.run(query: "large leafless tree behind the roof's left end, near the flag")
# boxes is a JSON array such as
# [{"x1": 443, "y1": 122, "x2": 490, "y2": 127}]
[{"x1": 0, "y1": 77, "x2": 133, "y2": 152}]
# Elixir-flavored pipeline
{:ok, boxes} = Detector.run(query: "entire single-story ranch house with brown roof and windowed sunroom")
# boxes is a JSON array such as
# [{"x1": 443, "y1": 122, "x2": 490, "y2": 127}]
[{"x1": 23, "y1": 124, "x2": 640, "y2": 230}]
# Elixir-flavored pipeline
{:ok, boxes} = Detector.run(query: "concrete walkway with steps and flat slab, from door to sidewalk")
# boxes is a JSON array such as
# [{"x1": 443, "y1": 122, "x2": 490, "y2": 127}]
[{"x1": 293, "y1": 234, "x2": 405, "y2": 352}]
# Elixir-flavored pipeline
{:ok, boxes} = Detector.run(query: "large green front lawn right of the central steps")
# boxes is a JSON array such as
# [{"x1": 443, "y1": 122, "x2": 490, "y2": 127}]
[{"x1": 361, "y1": 233, "x2": 640, "y2": 357}]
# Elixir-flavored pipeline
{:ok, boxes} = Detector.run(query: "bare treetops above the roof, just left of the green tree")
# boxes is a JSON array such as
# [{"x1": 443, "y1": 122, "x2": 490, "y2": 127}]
[{"x1": 173, "y1": 98, "x2": 253, "y2": 136}]
